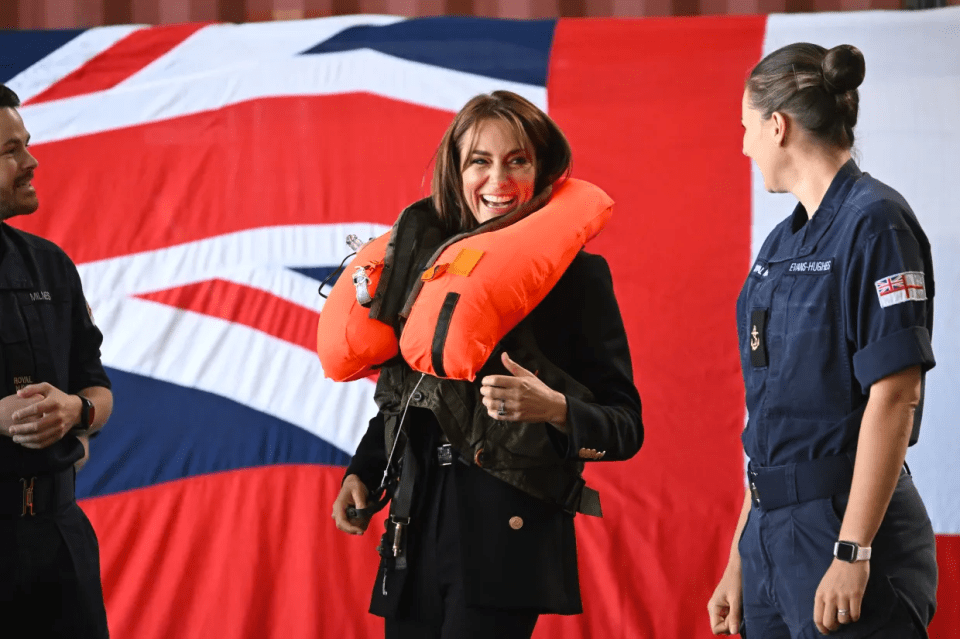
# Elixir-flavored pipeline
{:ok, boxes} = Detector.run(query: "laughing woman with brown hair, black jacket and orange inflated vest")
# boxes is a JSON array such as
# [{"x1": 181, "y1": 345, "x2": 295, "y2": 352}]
[{"x1": 329, "y1": 91, "x2": 643, "y2": 639}]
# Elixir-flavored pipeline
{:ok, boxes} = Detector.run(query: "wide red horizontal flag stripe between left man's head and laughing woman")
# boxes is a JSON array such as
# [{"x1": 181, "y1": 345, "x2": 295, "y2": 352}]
[{"x1": 13, "y1": 94, "x2": 452, "y2": 263}]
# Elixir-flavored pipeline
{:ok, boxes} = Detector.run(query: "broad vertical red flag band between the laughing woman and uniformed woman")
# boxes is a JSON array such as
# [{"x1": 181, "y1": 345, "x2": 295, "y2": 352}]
[{"x1": 537, "y1": 16, "x2": 765, "y2": 639}]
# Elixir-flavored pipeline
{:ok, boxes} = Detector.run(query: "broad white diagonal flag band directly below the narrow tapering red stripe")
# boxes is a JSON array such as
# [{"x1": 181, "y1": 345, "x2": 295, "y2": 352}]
[{"x1": 96, "y1": 297, "x2": 377, "y2": 455}]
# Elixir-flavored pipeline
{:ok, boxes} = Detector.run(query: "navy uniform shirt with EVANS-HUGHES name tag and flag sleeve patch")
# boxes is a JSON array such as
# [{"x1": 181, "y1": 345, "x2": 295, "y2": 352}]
[{"x1": 737, "y1": 160, "x2": 935, "y2": 466}]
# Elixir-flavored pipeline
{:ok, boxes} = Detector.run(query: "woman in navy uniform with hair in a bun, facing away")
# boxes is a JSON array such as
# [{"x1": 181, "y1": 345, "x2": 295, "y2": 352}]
[{"x1": 708, "y1": 43, "x2": 937, "y2": 639}]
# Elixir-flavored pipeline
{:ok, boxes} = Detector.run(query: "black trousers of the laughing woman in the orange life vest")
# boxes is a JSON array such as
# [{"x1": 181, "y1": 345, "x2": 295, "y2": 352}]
[{"x1": 378, "y1": 462, "x2": 538, "y2": 639}]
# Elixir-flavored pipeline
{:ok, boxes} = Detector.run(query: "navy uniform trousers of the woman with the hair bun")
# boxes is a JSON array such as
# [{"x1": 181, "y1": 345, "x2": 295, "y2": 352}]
[{"x1": 739, "y1": 474, "x2": 937, "y2": 639}]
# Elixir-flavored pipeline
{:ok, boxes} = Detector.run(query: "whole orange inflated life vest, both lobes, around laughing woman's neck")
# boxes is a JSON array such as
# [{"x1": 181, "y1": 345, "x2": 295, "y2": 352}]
[{"x1": 317, "y1": 178, "x2": 613, "y2": 381}]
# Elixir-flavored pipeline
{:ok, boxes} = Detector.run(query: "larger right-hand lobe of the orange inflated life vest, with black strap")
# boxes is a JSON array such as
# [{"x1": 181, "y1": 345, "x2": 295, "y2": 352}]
[{"x1": 400, "y1": 178, "x2": 613, "y2": 381}]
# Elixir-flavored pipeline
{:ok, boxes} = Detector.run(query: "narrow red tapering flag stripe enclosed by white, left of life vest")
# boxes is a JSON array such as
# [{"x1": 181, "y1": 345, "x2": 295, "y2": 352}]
[{"x1": 137, "y1": 279, "x2": 320, "y2": 351}]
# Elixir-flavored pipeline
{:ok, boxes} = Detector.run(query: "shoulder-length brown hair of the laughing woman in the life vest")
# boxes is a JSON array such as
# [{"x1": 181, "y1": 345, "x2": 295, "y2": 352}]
[{"x1": 430, "y1": 91, "x2": 572, "y2": 232}]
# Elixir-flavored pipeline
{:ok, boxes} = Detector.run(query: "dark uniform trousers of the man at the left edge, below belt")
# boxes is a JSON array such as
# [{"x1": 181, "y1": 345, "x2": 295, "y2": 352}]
[{"x1": 0, "y1": 502, "x2": 108, "y2": 639}]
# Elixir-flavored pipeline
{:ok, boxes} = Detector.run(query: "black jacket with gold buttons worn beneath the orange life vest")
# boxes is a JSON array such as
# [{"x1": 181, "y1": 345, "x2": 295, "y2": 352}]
[{"x1": 347, "y1": 252, "x2": 643, "y2": 614}]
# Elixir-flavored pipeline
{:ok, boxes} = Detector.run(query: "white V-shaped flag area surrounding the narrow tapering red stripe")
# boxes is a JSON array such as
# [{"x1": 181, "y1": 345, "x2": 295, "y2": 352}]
[{"x1": 78, "y1": 223, "x2": 389, "y2": 454}]
